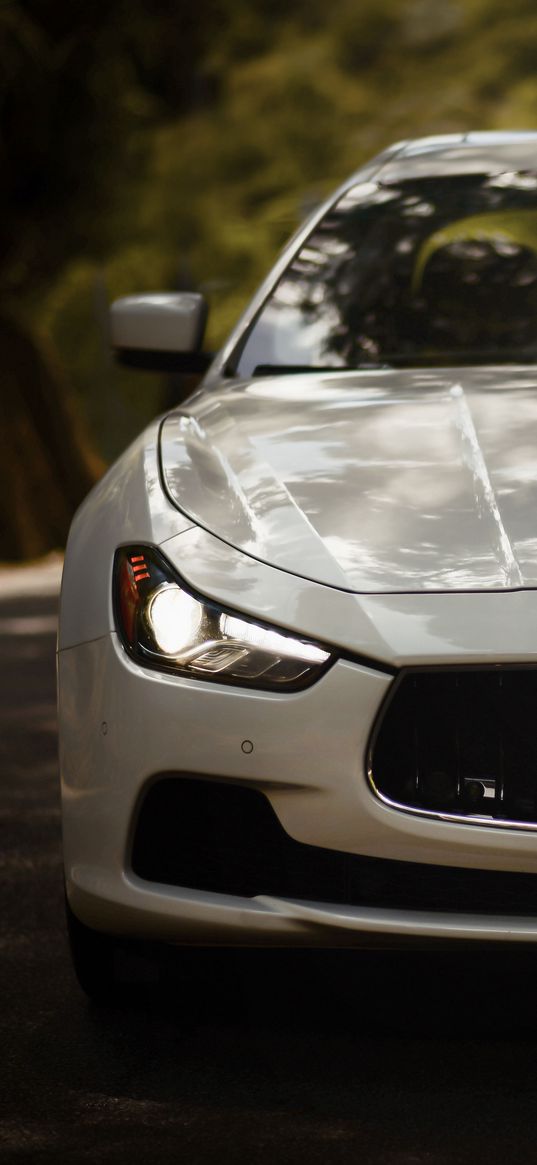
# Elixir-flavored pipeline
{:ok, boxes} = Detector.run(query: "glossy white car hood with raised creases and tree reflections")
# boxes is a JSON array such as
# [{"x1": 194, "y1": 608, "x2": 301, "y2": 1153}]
[{"x1": 161, "y1": 367, "x2": 537, "y2": 593}]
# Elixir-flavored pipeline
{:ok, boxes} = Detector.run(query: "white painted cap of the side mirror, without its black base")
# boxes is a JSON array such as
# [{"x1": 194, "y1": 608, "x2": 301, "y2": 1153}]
[{"x1": 111, "y1": 291, "x2": 206, "y2": 352}]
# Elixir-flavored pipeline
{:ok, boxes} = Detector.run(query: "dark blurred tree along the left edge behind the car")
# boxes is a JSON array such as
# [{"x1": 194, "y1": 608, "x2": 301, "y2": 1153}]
[{"x1": 0, "y1": 0, "x2": 222, "y2": 557}]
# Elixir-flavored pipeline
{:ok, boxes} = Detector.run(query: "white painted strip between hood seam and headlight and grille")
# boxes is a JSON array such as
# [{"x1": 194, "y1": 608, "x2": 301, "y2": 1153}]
[{"x1": 162, "y1": 527, "x2": 537, "y2": 668}]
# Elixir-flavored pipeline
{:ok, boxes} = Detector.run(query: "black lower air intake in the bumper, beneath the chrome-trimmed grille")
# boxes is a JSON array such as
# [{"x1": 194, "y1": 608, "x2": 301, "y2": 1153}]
[{"x1": 132, "y1": 776, "x2": 537, "y2": 916}]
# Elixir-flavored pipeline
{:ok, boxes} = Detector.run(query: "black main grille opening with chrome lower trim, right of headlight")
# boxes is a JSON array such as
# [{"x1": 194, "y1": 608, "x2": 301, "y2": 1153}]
[{"x1": 370, "y1": 668, "x2": 537, "y2": 825}]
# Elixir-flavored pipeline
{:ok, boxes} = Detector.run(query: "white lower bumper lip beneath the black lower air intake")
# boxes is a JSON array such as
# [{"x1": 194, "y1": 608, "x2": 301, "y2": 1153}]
[{"x1": 70, "y1": 868, "x2": 537, "y2": 947}]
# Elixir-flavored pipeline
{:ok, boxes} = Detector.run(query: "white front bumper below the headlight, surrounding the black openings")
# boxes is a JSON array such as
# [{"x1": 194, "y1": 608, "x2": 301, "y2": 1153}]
[{"x1": 58, "y1": 634, "x2": 537, "y2": 946}]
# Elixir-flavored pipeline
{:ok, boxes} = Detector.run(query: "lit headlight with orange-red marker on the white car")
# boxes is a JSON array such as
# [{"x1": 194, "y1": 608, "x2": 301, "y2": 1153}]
[{"x1": 114, "y1": 546, "x2": 333, "y2": 690}]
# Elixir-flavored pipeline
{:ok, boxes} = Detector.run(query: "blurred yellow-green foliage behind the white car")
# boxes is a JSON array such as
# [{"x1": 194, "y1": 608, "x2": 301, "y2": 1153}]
[{"x1": 5, "y1": 0, "x2": 537, "y2": 459}]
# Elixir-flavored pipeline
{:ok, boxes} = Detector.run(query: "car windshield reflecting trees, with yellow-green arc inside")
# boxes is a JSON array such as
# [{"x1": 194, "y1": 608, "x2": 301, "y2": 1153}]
[{"x1": 236, "y1": 171, "x2": 537, "y2": 376}]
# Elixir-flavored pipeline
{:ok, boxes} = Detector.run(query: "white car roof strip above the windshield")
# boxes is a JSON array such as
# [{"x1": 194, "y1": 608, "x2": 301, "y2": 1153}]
[{"x1": 368, "y1": 130, "x2": 537, "y2": 182}]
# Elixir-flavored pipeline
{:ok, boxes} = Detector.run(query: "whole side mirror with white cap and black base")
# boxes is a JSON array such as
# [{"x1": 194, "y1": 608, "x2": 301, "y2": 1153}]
[{"x1": 111, "y1": 291, "x2": 212, "y2": 372}]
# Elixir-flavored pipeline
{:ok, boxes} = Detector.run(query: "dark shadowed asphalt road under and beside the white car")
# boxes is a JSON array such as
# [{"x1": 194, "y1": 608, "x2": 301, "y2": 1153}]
[{"x1": 5, "y1": 568, "x2": 537, "y2": 1165}]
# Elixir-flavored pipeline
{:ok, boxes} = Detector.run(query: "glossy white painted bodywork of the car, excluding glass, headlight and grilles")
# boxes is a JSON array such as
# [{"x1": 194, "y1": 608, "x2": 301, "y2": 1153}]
[{"x1": 58, "y1": 135, "x2": 537, "y2": 946}]
